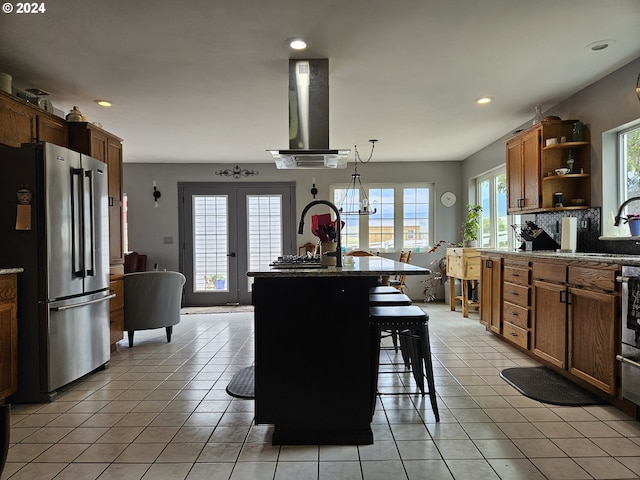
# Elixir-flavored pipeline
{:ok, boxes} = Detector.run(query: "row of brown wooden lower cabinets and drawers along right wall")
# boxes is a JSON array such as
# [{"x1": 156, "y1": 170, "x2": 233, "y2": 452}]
[{"x1": 481, "y1": 252, "x2": 621, "y2": 397}]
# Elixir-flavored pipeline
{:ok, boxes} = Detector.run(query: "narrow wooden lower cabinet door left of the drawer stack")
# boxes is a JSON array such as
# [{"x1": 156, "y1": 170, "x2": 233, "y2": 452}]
[{"x1": 480, "y1": 255, "x2": 502, "y2": 335}]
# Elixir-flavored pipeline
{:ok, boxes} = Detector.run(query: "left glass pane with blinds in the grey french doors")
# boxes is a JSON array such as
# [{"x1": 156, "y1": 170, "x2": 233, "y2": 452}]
[{"x1": 192, "y1": 195, "x2": 229, "y2": 292}]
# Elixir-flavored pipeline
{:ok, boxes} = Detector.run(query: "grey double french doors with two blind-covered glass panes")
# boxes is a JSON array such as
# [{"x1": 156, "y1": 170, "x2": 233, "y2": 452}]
[{"x1": 178, "y1": 183, "x2": 295, "y2": 305}]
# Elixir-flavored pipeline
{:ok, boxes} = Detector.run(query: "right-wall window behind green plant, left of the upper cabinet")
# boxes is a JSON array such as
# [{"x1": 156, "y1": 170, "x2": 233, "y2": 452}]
[{"x1": 476, "y1": 167, "x2": 510, "y2": 248}]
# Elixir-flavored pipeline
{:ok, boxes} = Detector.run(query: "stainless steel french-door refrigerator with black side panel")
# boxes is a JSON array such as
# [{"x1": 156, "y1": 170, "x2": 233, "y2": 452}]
[{"x1": 0, "y1": 143, "x2": 110, "y2": 403}]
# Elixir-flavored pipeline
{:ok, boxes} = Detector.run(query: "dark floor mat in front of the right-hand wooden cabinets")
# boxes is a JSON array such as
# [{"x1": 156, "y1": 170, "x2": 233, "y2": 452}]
[{"x1": 500, "y1": 367, "x2": 606, "y2": 406}]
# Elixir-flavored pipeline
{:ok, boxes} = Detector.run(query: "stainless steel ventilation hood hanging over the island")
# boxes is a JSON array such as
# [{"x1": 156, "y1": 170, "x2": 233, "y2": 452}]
[{"x1": 267, "y1": 58, "x2": 351, "y2": 169}]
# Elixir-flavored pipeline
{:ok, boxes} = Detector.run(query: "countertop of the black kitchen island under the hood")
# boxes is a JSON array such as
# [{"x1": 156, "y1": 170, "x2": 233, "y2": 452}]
[{"x1": 247, "y1": 256, "x2": 431, "y2": 277}]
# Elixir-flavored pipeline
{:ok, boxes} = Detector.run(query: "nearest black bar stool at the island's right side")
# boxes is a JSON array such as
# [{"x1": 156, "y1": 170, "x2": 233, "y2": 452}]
[{"x1": 369, "y1": 305, "x2": 440, "y2": 422}]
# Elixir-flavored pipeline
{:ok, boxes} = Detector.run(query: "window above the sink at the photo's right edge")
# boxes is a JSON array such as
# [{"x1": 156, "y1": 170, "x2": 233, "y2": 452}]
[{"x1": 618, "y1": 125, "x2": 640, "y2": 213}]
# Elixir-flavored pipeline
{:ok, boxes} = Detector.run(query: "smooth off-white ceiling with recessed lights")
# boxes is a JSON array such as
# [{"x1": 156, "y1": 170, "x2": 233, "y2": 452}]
[{"x1": 0, "y1": 0, "x2": 640, "y2": 163}]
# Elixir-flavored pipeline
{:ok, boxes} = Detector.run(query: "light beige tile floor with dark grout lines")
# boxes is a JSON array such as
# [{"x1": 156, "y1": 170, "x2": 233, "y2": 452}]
[{"x1": 2, "y1": 303, "x2": 640, "y2": 480}]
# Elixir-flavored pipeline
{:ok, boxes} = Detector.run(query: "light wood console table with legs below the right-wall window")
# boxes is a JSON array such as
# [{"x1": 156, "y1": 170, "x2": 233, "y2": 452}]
[{"x1": 447, "y1": 248, "x2": 480, "y2": 317}]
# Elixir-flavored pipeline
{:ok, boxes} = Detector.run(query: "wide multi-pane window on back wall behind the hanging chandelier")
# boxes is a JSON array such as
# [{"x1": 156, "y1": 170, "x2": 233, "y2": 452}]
[{"x1": 331, "y1": 184, "x2": 434, "y2": 252}]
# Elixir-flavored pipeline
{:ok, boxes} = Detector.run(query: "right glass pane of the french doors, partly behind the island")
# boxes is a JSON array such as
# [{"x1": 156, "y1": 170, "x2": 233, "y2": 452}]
[{"x1": 247, "y1": 195, "x2": 283, "y2": 284}]
